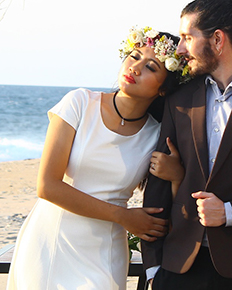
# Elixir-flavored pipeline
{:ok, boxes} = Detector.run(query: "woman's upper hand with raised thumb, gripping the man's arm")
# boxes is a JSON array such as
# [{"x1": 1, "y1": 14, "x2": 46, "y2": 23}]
[{"x1": 150, "y1": 137, "x2": 185, "y2": 197}]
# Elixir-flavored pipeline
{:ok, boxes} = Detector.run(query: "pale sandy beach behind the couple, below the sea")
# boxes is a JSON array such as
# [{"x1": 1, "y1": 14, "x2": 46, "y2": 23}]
[{"x1": 0, "y1": 159, "x2": 149, "y2": 290}]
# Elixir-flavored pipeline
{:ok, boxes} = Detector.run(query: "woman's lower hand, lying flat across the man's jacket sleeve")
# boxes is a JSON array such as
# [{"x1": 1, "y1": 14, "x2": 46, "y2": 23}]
[{"x1": 118, "y1": 208, "x2": 168, "y2": 242}]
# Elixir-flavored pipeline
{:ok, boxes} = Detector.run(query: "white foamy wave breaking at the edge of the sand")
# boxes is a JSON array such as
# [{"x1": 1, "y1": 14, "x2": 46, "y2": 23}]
[{"x1": 0, "y1": 138, "x2": 44, "y2": 162}]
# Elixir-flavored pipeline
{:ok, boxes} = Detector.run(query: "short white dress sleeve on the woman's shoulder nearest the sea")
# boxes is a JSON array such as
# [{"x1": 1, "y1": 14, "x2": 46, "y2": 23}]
[{"x1": 48, "y1": 89, "x2": 87, "y2": 130}]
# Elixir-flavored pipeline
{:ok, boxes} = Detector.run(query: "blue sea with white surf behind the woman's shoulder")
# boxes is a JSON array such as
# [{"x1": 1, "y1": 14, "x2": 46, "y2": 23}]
[{"x1": 0, "y1": 85, "x2": 111, "y2": 162}]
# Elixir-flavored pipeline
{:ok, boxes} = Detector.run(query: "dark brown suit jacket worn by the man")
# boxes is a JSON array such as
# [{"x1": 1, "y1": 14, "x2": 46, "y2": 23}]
[{"x1": 142, "y1": 77, "x2": 232, "y2": 278}]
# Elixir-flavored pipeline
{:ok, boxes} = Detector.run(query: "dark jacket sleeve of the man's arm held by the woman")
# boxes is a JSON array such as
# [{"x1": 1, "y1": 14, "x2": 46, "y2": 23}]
[{"x1": 141, "y1": 96, "x2": 178, "y2": 269}]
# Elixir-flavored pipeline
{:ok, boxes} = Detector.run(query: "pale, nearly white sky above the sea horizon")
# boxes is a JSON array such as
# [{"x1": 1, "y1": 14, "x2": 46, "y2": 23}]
[{"x1": 0, "y1": 0, "x2": 190, "y2": 88}]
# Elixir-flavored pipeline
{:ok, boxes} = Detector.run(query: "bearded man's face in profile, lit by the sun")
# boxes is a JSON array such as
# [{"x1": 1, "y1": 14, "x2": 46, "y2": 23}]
[{"x1": 177, "y1": 13, "x2": 218, "y2": 76}]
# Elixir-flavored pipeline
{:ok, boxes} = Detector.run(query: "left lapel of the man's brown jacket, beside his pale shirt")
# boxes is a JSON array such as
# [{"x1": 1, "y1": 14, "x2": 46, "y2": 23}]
[{"x1": 192, "y1": 78, "x2": 209, "y2": 181}]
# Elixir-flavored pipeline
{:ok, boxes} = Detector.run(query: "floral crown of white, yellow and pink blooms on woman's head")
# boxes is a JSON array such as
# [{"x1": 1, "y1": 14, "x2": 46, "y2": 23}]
[{"x1": 119, "y1": 27, "x2": 189, "y2": 82}]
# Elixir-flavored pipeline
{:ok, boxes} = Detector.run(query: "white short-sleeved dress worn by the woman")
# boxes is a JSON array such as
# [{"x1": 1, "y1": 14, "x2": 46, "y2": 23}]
[{"x1": 7, "y1": 89, "x2": 160, "y2": 290}]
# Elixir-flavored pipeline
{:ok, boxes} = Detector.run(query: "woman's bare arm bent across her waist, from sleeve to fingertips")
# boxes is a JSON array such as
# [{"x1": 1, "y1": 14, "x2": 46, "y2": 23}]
[{"x1": 37, "y1": 115, "x2": 167, "y2": 241}]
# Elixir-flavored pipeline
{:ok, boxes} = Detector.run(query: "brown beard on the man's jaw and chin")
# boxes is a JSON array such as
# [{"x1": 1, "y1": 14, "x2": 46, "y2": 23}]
[{"x1": 189, "y1": 41, "x2": 219, "y2": 77}]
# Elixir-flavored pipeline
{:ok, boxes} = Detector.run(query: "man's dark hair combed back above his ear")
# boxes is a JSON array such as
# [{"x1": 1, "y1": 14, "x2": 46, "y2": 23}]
[{"x1": 181, "y1": 0, "x2": 232, "y2": 44}]
